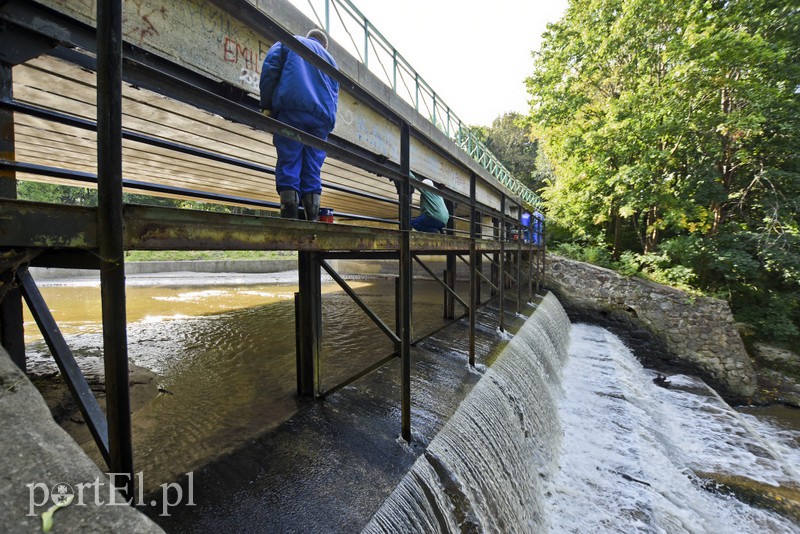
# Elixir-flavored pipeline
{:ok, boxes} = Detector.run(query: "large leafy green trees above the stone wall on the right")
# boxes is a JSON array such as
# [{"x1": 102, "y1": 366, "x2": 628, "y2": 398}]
[{"x1": 526, "y1": 0, "x2": 800, "y2": 341}]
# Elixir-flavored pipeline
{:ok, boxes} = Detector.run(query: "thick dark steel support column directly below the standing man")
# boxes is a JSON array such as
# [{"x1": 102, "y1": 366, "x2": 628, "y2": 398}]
[{"x1": 295, "y1": 252, "x2": 322, "y2": 397}]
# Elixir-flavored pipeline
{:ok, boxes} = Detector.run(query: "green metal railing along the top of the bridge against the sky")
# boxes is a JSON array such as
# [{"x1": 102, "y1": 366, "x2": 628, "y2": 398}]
[{"x1": 290, "y1": 0, "x2": 542, "y2": 208}]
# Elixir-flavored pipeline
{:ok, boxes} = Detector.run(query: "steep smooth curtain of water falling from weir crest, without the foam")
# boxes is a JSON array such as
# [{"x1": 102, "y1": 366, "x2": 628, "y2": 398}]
[{"x1": 364, "y1": 295, "x2": 570, "y2": 533}]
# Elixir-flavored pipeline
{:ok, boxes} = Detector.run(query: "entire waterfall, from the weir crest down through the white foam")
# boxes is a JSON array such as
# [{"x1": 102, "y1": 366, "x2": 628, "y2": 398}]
[{"x1": 363, "y1": 295, "x2": 800, "y2": 534}]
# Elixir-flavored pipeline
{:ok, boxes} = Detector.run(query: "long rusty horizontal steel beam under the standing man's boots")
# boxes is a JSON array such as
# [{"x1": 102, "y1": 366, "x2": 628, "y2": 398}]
[{"x1": 0, "y1": 199, "x2": 510, "y2": 259}]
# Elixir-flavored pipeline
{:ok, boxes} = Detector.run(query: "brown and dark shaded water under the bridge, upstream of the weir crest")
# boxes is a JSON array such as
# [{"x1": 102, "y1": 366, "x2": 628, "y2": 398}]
[{"x1": 29, "y1": 279, "x2": 532, "y2": 532}]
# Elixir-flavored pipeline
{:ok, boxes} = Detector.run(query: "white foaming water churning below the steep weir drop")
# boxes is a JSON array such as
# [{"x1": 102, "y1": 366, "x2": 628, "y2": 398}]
[{"x1": 544, "y1": 325, "x2": 800, "y2": 534}]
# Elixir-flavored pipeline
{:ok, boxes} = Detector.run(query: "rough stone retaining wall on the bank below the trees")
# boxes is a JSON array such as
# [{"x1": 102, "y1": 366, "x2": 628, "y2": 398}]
[{"x1": 545, "y1": 254, "x2": 757, "y2": 400}]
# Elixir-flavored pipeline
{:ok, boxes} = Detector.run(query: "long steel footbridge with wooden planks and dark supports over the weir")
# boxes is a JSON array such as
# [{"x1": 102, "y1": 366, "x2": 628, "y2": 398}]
[{"x1": 0, "y1": 0, "x2": 544, "y2": 498}]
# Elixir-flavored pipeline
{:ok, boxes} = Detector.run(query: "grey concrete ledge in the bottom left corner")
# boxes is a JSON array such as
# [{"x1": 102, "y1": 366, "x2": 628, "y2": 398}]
[{"x1": 0, "y1": 349, "x2": 164, "y2": 534}]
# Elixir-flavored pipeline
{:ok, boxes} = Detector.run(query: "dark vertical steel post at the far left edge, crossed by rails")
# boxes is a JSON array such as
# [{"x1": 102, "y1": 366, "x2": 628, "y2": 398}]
[{"x1": 0, "y1": 63, "x2": 27, "y2": 372}]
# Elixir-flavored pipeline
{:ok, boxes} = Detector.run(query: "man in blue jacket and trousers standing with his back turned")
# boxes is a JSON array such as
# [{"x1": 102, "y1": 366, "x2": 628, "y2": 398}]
[{"x1": 260, "y1": 29, "x2": 339, "y2": 221}]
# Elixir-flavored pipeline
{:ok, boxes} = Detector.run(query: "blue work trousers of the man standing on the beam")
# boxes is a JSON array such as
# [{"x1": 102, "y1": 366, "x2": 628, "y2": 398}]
[{"x1": 273, "y1": 111, "x2": 330, "y2": 198}]
